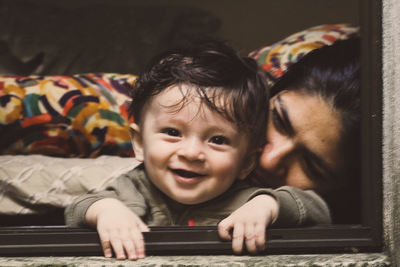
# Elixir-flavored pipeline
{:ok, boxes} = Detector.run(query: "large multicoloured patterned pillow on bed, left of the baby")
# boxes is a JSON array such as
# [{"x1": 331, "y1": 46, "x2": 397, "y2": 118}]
[{"x1": 0, "y1": 73, "x2": 136, "y2": 157}]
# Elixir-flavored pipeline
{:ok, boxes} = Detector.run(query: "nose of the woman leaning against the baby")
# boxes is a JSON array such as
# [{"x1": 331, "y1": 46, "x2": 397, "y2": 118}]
[{"x1": 260, "y1": 139, "x2": 295, "y2": 175}]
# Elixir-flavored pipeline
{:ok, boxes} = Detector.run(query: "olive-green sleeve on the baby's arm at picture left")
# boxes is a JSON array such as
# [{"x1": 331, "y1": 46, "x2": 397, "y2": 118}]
[{"x1": 64, "y1": 171, "x2": 146, "y2": 227}]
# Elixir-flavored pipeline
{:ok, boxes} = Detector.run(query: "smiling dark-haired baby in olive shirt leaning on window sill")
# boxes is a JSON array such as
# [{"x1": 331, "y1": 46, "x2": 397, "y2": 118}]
[{"x1": 65, "y1": 42, "x2": 330, "y2": 260}]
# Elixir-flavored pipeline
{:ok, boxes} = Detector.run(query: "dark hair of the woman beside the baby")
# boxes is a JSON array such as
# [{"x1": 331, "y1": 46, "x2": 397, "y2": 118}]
[{"x1": 271, "y1": 37, "x2": 361, "y2": 223}]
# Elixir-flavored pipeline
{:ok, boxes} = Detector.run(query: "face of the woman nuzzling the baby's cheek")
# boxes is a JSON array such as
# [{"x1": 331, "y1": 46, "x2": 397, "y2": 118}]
[{"x1": 258, "y1": 90, "x2": 342, "y2": 193}]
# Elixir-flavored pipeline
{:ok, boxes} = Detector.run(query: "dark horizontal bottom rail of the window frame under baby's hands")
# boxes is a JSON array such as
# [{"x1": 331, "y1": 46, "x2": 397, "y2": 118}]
[{"x1": 0, "y1": 225, "x2": 380, "y2": 256}]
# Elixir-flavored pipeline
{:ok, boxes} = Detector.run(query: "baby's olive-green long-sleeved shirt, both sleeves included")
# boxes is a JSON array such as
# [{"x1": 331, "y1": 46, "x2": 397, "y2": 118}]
[{"x1": 65, "y1": 164, "x2": 331, "y2": 227}]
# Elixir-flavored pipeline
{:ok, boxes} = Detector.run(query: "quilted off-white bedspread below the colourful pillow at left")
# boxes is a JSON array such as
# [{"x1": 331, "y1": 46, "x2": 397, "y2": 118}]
[{"x1": 0, "y1": 155, "x2": 139, "y2": 215}]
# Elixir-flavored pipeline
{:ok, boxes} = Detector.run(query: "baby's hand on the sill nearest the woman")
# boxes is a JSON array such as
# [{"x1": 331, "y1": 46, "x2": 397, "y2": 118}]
[{"x1": 218, "y1": 195, "x2": 278, "y2": 254}]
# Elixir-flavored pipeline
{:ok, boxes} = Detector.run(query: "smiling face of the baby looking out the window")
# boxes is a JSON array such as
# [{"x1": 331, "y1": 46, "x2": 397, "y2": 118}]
[{"x1": 135, "y1": 85, "x2": 249, "y2": 204}]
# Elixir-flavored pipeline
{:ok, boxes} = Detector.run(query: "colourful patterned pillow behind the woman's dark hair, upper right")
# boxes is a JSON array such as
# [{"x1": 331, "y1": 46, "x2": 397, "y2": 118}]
[{"x1": 249, "y1": 24, "x2": 359, "y2": 85}]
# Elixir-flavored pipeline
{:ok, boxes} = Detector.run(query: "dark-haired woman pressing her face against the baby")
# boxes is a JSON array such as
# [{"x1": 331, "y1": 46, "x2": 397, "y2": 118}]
[{"x1": 252, "y1": 38, "x2": 360, "y2": 222}]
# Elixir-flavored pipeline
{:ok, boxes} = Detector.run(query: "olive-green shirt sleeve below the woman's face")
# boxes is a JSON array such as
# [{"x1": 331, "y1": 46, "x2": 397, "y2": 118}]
[{"x1": 247, "y1": 186, "x2": 332, "y2": 227}]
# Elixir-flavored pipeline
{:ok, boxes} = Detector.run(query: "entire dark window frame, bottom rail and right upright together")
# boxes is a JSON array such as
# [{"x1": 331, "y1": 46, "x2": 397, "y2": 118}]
[{"x1": 0, "y1": 0, "x2": 382, "y2": 256}]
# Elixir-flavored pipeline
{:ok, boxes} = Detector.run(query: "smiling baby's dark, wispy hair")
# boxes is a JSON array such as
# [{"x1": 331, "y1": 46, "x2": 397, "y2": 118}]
[{"x1": 129, "y1": 41, "x2": 269, "y2": 152}]
